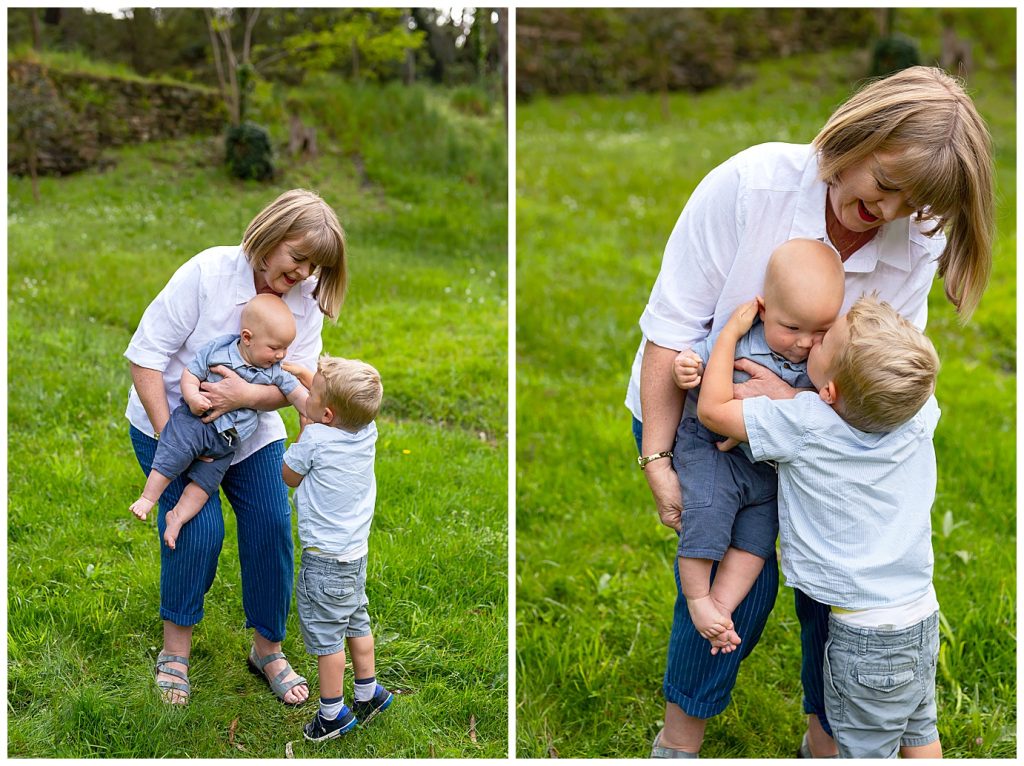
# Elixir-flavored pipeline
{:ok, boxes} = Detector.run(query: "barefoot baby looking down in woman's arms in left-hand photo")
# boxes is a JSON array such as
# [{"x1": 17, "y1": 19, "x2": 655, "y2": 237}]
[{"x1": 130, "y1": 294, "x2": 308, "y2": 549}]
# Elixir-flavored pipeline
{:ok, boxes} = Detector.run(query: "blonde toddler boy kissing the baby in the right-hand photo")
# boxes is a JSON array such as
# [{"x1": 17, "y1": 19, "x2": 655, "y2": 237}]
[{"x1": 697, "y1": 296, "x2": 942, "y2": 758}]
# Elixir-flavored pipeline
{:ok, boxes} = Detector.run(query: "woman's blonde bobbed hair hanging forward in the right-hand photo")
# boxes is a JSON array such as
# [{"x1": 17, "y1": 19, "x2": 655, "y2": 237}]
[{"x1": 814, "y1": 67, "x2": 994, "y2": 321}]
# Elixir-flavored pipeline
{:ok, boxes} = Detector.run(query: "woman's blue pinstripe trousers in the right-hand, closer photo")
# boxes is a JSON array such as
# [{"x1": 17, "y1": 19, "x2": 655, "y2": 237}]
[{"x1": 633, "y1": 418, "x2": 831, "y2": 733}]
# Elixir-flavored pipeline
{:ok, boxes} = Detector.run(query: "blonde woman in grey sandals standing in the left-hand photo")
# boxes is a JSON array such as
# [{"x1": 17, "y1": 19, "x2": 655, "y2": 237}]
[{"x1": 125, "y1": 189, "x2": 347, "y2": 705}]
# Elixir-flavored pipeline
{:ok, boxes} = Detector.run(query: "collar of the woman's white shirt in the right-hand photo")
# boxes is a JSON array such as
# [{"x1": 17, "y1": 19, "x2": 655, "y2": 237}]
[{"x1": 790, "y1": 150, "x2": 916, "y2": 273}]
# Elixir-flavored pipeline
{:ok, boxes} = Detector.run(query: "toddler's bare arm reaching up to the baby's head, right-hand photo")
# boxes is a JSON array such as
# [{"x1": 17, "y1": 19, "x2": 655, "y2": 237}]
[{"x1": 697, "y1": 299, "x2": 760, "y2": 441}]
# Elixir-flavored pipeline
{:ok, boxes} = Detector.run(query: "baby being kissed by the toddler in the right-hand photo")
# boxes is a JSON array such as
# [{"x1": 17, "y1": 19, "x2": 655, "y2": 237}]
[{"x1": 673, "y1": 239, "x2": 844, "y2": 654}]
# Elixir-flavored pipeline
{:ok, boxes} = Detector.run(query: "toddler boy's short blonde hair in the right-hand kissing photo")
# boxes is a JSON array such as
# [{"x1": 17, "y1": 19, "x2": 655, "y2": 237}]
[{"x1": 829, "y1": 294, "x2": 939, "y2": 433}]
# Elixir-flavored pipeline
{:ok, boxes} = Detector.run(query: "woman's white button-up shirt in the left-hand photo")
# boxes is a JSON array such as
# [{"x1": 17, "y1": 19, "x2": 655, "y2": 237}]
[{"x1": 125, "y1": 246, "x2": 324, "y2": 464}]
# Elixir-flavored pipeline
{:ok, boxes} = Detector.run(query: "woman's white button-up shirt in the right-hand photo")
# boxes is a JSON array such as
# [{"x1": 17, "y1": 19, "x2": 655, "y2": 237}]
[{"x1": 626, "y1": 143, "x2": 945, "y2": 419}]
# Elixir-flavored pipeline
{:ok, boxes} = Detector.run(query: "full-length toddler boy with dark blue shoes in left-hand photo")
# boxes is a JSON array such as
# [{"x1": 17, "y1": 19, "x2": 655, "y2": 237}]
[{"x1": 282, "y1": 355, "x2": 392, "y2": 741}]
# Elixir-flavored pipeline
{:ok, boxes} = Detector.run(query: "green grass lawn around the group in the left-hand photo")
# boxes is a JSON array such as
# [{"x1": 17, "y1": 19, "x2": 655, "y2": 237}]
[{"x1": 7, "y1": 74, "x2": 508, "y2": 758}]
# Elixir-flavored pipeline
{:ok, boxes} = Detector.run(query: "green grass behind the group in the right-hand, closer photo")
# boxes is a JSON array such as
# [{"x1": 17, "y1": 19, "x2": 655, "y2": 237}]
[{"x1": 516, "y1": 52, "x2": 1017, "y2": 758}]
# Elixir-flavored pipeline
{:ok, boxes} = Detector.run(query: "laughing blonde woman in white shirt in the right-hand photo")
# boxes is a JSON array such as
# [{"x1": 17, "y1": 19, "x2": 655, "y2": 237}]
[{"x1": 626, "y1": 67, "x2": 993, "y2": 758}]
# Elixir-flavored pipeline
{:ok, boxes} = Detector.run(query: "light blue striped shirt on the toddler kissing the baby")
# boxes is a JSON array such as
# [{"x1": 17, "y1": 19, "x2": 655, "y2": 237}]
[{"x1": 743, "y1": 392, "x2": 939, "y2": 609}]
